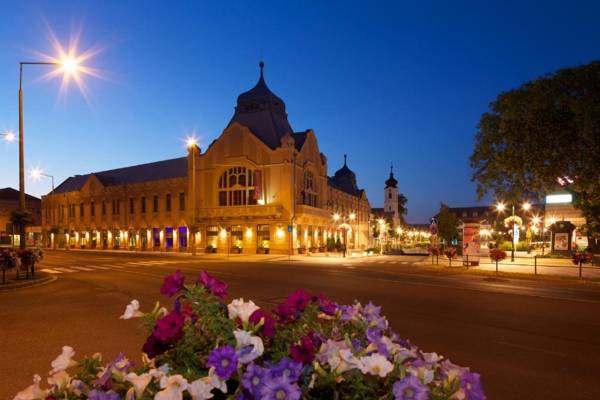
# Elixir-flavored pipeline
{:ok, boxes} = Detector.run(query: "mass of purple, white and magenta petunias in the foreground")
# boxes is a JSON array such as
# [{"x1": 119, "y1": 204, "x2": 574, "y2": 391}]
[{"x1": 15, "y1": 271, "x2": 485, "y2": 400}]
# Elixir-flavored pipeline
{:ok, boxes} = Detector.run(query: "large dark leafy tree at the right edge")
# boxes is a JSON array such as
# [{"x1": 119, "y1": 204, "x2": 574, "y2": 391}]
[{"x1": 470, "y1": 61, "x2": 600, "y2": 248}]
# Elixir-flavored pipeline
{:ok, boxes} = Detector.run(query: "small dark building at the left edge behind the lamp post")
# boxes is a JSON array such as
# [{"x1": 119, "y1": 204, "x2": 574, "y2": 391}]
[{"x1": 0, "y1": 187, "x2": 42, "y2": 247}]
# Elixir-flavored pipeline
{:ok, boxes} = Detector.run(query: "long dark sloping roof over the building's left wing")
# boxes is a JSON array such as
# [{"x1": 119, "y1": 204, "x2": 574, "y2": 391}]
[{"x1": 54, "y1": 157, "x2": 187, "y2": 193}]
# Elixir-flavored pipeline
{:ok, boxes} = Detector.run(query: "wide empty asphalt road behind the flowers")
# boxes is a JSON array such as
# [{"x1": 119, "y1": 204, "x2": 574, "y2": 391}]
[{"x1": 0, "y1": 252, "x2": 600, "y2": 400}]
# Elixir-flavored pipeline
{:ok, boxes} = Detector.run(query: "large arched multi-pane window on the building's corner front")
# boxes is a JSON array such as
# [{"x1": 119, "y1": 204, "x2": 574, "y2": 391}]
[{"x1": 219, "y1": 167, "x2": 256, "y2": 207}]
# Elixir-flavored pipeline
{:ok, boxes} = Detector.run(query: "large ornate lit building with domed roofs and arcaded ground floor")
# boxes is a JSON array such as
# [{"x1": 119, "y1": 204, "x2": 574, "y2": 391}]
[{"x1": 42, "y1": 62, "x2": 370, "y2": 254}]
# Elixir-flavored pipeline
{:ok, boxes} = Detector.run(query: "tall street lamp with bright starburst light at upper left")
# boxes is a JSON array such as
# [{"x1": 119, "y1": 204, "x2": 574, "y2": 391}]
[{"x1": 19, "y1": 56, "x2": 79, "y2": 249}]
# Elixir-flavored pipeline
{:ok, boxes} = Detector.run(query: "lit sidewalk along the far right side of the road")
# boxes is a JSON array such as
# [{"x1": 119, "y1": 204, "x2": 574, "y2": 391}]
[{"x1": 421, "y1": 256, "x2": 600, "y2": 280}]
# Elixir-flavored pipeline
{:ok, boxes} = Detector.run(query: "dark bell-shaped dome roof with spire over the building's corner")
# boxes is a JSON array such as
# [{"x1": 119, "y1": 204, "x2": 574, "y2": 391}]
[{"x1": 227, "y1": 61, "x2": 294, "y2": 149}]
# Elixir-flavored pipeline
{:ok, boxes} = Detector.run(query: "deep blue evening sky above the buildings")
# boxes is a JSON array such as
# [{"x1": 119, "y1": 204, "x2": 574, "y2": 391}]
[{"x1": 0, "y1": 1, "x2": 600, "y2": 222}]
